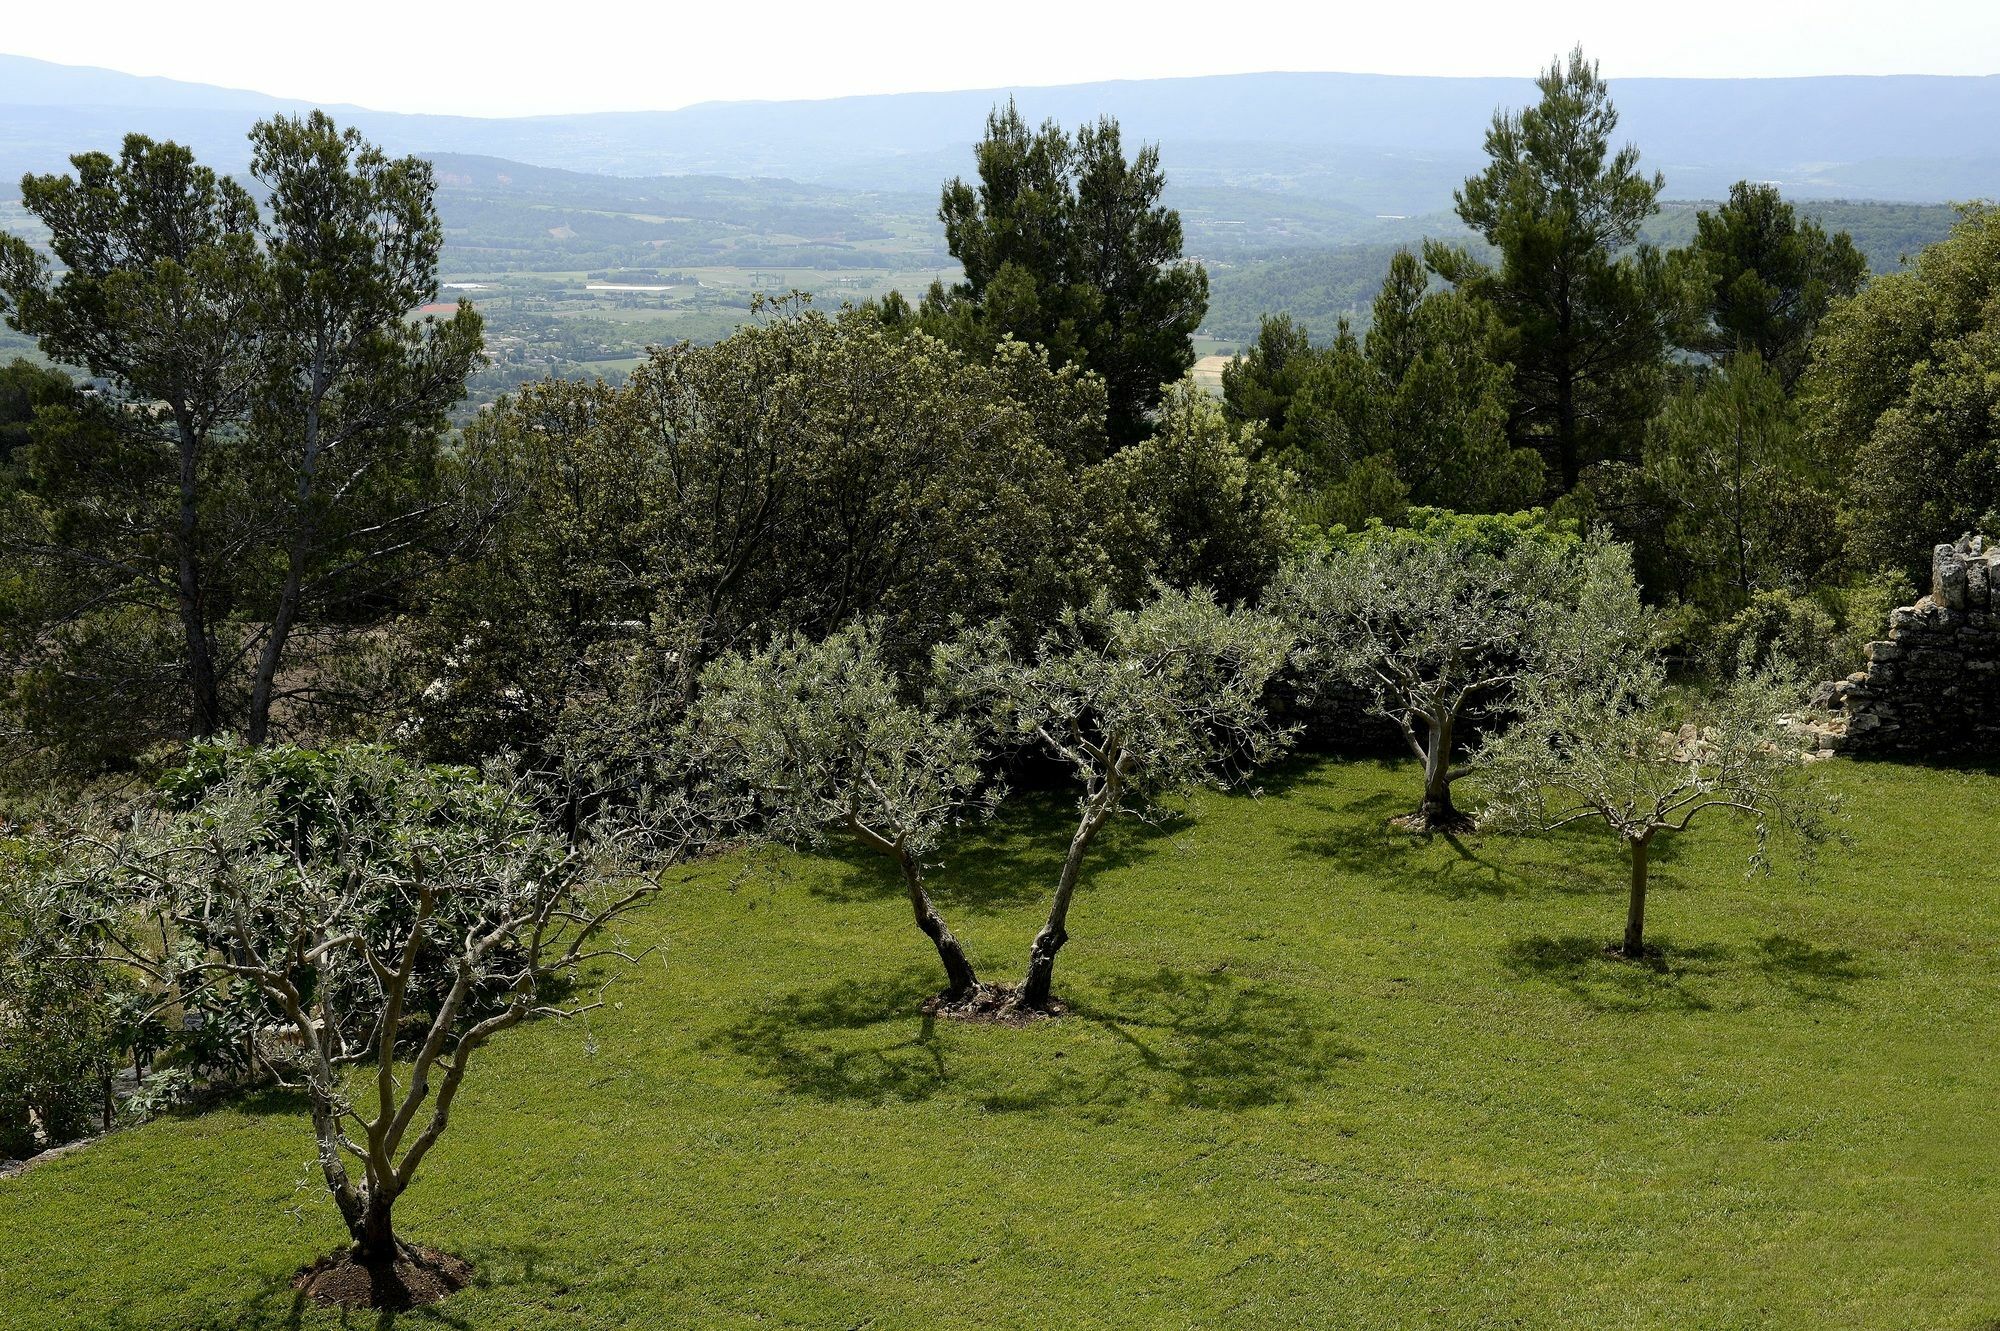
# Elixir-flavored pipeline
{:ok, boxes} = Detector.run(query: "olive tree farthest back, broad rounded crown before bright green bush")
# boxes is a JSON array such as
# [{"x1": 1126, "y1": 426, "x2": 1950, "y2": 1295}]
[{"x1": 1268, "y1": 514, "x2": 1612, "y2": 831}]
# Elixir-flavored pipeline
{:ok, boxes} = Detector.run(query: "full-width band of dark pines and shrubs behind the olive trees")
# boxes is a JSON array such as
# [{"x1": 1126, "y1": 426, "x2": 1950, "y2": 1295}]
[{"x1": 0, "y1": 54, "x2": 2000, "y2": 771}]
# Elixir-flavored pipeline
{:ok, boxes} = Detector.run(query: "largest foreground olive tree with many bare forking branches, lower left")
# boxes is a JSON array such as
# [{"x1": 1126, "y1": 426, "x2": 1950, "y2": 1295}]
[{"x1": 64, "y1": 743, "x2": 696, "y2": 1299}]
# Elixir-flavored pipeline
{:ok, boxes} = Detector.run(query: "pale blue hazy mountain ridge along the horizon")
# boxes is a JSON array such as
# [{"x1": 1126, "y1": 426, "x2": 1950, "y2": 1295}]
[{"x1": 11, "y1": 56, "x2": 2000, "y2": 214}]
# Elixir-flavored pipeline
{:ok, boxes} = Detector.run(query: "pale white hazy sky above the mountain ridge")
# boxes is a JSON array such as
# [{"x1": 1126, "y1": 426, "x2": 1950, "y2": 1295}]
[{"x1": 0, "y1": 0, "x2": 2000, "y2": 116}]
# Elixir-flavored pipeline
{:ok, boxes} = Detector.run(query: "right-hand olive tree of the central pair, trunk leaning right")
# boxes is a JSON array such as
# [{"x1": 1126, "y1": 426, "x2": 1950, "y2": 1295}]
[{"x1": 938, "y1": 588, "x2": 1292, "y2": 1013}]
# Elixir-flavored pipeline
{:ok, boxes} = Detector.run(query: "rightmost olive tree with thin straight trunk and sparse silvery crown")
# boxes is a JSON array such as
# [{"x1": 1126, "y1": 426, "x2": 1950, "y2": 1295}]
[{"x1": 1480, "y1": 559, "x2": 1834, "y2": 959}]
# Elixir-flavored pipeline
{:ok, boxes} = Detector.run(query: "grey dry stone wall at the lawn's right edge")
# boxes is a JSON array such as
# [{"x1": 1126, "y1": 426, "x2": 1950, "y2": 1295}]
[{"x1": 1816, "y1": 536, "x2": 2000, "y2": 755}]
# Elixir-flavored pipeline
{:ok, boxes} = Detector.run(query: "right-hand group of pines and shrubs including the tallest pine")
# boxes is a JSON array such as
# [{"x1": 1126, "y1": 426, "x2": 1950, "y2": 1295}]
[{"x1": 1224, "y1": 52, "x2": 2000, "y2": 673}]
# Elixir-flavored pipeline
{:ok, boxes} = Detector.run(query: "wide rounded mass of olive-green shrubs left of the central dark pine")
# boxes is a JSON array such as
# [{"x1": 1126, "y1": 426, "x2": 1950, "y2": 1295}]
[{"x1": 412, "y1": 295, "x2": 1112, "y2": 761}]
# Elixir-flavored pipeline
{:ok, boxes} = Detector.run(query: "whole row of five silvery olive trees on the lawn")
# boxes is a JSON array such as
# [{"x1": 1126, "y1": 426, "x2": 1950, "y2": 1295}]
[{"x1": 6, "y1": 520, "x2": 1826, "y2": 1279}]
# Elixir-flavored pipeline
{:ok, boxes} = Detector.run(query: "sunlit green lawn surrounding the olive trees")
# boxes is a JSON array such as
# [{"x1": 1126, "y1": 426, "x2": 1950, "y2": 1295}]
[{"x1": 0, "y1": 763, "x2": 2000, "y2": 1331}]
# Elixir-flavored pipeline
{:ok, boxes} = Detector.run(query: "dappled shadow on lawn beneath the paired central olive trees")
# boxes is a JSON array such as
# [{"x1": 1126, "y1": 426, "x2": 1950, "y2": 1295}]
[{"x1": 710, "y1": 967, "x2": 1356, "y2": 1115}]
